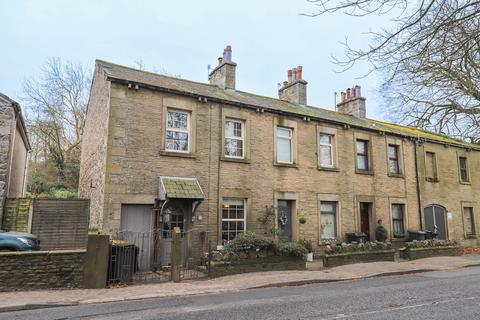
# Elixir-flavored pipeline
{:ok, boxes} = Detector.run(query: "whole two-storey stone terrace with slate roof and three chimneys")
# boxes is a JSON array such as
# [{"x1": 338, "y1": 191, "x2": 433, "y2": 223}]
[{"x1": 79, "y1": 46, "x2": 480, "y2": 269}]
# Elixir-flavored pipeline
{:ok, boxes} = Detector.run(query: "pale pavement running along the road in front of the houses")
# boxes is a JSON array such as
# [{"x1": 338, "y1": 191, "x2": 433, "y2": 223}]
[{"x1": 0, "y1": 255, "x2": 480, "y2": 312}]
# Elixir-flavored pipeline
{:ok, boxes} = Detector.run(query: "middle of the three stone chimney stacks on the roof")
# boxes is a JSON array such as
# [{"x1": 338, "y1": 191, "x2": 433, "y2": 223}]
[{"x1": 278, "y1": 66, "x2": 307, "y2": 105}]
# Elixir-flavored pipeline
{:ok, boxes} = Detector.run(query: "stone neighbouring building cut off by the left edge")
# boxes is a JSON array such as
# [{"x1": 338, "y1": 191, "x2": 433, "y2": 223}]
[{"x1": 0, "y1": 93, "x2": 31, "y2": 222}]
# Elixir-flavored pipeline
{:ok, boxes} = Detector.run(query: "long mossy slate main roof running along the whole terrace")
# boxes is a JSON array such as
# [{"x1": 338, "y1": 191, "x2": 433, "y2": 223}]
[{"x1": 96, "y1": 60, "x2": 480, "y2": 150}]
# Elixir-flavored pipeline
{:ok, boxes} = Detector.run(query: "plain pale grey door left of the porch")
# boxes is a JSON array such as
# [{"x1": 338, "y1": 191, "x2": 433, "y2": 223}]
[{"x1": 120, "y1": 204, "x2": 154, "y2": 271}]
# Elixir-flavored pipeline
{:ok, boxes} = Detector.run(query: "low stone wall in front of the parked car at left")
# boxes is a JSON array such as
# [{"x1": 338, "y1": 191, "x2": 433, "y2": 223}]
[{"x1": 0, "y1": 250, "x2": 86, "y2": 291}]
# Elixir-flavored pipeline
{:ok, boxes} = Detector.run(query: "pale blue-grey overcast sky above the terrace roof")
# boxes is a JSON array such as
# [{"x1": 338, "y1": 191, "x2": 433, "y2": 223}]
[{"x1": 0, "y1": 0, "x2": 396, "y2": 119}]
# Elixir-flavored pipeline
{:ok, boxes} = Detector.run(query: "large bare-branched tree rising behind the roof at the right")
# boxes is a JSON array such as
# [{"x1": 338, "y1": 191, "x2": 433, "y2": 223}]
[{"x1": 307, "y1": 0, "x2": 480, "y2": 143}]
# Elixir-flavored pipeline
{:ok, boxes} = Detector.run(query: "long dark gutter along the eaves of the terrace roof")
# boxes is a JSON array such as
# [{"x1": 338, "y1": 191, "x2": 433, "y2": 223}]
[{"x1": 107, "y1": 75, "x2": 480, "y2": 151}]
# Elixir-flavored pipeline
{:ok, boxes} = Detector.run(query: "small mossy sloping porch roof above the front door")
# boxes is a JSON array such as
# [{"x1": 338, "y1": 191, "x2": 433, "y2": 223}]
[{"x1": 160, "y1": 177, "x2": 205, "y2": 199}]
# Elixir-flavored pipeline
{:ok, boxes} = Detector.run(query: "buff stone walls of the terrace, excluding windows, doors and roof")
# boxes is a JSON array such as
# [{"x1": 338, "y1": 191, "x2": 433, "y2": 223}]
[{"x1": 80, "y1": 59, "x2": 480, "y2": 262}]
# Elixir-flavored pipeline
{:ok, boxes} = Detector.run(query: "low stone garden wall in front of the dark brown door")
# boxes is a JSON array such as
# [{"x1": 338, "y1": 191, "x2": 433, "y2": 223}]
[{"x1": 323, "y1": 249, "x2": 395, "y2": 267}]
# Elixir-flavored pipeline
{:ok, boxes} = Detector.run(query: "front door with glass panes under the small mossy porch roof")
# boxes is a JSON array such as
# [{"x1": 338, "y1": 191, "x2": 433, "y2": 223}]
[{"x1": 160, "y1": 202, "x2": 187, "y2": 266}]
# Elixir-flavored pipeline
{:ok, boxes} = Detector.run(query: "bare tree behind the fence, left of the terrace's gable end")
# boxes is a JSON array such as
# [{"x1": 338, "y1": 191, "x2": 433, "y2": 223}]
[{"x1": 22, "y1": 58, "x2": 91, "y2": 192}]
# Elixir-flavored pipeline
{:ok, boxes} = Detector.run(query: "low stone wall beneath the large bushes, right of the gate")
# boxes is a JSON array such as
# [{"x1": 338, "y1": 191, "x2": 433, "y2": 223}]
[{"x1": 210, "y1": 256, "x2": 306, "y2": 277}]
